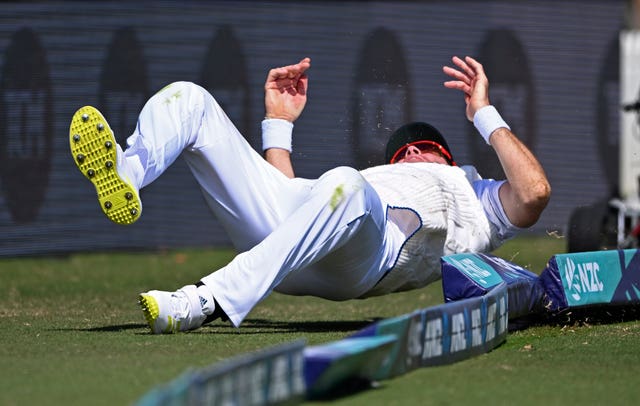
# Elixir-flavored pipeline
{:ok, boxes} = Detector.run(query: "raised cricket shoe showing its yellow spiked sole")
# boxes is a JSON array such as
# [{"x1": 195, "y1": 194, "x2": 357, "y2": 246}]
[{"x1": 69, "y1": 106, "x2": 142, "y2": 224}]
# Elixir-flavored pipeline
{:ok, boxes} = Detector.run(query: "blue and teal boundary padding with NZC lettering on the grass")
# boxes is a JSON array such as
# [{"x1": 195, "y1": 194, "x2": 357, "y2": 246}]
[{"x1": 138, "y1": 249, "x2": 640, "y2": 406}]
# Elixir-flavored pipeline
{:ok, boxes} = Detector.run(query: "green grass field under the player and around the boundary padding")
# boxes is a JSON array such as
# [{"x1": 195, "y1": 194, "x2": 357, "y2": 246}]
[{"x1": 0, "y1": 236, "x2": 640, "y2": 405}]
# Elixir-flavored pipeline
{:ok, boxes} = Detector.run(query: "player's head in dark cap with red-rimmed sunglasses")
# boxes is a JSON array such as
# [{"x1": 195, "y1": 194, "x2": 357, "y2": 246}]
[{"x1": 385, "y1": 122, "x2": 456, "y2": 166}]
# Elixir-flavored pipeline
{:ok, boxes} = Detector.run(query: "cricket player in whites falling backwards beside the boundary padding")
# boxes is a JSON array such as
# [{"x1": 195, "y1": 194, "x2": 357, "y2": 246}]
[{"x1": 69, "y1": 57, "x2": 550, "y2": 333}]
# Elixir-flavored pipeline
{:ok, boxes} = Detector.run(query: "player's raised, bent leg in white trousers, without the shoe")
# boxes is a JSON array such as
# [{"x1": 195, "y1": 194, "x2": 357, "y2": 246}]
[{"x1": 125, "y1": 82, "x2": 303, "y2": 251}]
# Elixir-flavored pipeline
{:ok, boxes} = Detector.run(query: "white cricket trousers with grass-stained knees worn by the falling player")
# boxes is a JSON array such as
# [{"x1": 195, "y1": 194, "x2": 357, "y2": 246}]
[{"x1": 124, "y1": 82, "x2": 400, "y2": 326}]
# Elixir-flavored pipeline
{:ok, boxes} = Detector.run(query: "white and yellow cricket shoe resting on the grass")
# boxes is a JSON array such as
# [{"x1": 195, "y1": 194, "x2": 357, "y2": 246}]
[{"x1": 138, "y1": 285, "x2": 206, "y2": 334}]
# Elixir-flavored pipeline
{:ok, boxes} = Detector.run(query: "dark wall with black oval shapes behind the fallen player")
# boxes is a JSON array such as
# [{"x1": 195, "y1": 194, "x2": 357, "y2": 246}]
[{"x1": 0, "y1": 0, "x2": 625, "y2": 256}]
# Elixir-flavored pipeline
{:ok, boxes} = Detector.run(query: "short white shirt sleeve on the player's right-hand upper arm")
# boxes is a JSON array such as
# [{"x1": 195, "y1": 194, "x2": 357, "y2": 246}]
[{"x1": 471, "y1": 179, "x2": 523, "y2": 240}]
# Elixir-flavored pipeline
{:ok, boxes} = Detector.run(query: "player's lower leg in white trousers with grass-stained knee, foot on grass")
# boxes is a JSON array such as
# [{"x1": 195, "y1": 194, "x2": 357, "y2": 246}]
[{"x1": 142, "y1": 168, "x2": 396, "y2": 331}]
